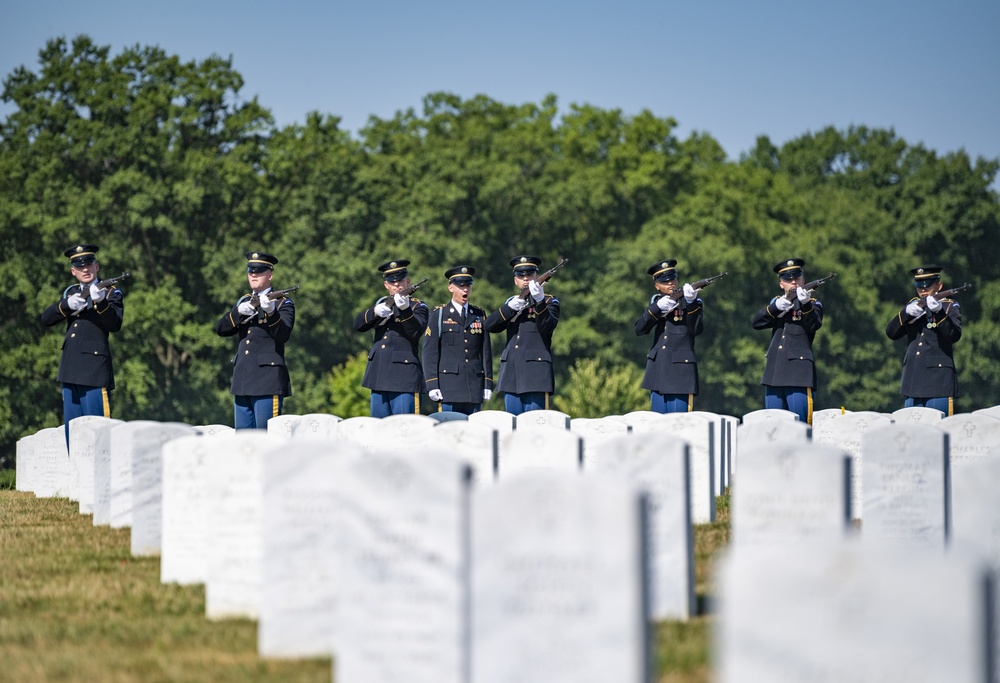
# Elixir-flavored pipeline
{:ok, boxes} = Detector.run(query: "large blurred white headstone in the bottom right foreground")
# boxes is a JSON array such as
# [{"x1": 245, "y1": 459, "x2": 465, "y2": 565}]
[{"x1": 715, "y1": 544, "x2": 990, "y2": 683}]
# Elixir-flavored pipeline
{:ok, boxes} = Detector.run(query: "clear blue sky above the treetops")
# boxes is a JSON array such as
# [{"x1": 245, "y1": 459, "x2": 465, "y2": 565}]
[{"x1": 0, "y1": 0, "x2": 1000, "y2": 170}]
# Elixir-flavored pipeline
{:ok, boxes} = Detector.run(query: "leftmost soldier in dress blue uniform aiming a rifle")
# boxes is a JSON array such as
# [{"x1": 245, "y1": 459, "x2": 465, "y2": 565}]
[{"x1": 42, "y1": 244, "x2": 125, "y2": 445}]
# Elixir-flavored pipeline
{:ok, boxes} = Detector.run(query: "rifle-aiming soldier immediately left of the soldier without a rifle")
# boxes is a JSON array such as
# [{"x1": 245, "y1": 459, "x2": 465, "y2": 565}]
[{"x1": 354, "y1": 259, "x2": 428, "y2": 417}]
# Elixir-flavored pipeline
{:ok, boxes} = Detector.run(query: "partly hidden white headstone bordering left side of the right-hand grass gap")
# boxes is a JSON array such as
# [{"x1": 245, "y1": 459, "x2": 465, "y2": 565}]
[{"x1": 632, "y1": 413, "x2": 717, "y2": 524}]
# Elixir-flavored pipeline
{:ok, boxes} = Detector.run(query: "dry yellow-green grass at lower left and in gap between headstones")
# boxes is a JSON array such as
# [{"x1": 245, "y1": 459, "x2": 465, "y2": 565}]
[{"x1": 0, "y1": 488, "x2": 729, "y2": 683}]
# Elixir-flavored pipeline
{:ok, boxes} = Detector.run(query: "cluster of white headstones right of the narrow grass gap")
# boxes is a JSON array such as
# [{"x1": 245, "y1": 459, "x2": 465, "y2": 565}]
[{"x1": 728, "y1": 409, "x2": 1000, "y2": 683}]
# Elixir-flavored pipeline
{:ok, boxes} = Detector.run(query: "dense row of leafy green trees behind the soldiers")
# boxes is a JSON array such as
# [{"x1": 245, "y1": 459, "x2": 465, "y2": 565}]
[{"x1": 0, "y1": 36, "x2": 1000, "y2": 456}]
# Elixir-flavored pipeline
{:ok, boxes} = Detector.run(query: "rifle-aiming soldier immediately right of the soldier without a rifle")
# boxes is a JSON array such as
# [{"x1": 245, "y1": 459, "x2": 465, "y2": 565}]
[{"x1": 486, "y1": 255, "x2": 559, "y2": 415}]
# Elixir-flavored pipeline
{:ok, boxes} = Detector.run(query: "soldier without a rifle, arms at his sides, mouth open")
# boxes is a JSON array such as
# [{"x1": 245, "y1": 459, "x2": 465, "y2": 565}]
[{"x1": 422, "y1": 266, "x2": 493, "y2": 415}]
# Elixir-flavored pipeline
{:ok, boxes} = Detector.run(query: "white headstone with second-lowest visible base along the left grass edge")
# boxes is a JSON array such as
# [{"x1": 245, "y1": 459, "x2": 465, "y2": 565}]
[{"x1": 204, "y1": 436, "x2": 276, "y2": 620}]
